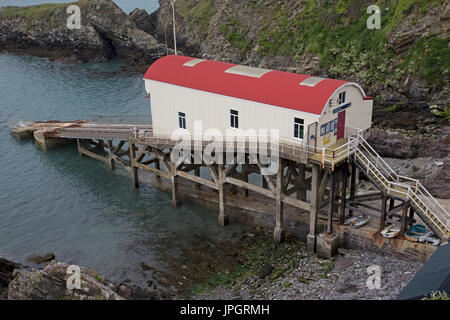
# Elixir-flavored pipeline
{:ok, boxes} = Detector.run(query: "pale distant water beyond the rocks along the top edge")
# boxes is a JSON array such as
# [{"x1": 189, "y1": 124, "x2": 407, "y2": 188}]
[{"x1": 0, "y1": 0, "x2": 159, "y2": 13}]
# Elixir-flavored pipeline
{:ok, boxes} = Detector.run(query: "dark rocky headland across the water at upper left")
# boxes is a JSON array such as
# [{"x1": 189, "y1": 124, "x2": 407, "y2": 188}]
[{"x1": 0, "y1": 0, "x2": 166, "y2": 65}]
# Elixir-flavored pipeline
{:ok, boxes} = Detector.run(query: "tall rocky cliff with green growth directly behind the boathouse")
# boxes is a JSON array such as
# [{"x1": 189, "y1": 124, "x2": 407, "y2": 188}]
[{"x1": 155, "y1": 0, "x2": 450, "y2": 131}]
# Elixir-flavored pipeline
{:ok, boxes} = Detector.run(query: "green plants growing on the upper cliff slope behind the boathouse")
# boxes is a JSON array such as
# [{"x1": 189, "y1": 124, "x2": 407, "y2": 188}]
[{"x1": 185, "y1": 0, "x2": 450, "y2": 87}]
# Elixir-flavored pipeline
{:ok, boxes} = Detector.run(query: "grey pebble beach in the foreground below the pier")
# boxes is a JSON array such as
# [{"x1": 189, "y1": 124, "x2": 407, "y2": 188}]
[{"x1": 193, "y1": 247, "x2": 422, "y2": 300}]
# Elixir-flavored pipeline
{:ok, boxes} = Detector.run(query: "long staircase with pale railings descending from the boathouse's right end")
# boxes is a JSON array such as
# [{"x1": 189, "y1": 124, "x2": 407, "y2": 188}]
[{"x1": 348, "y1": 132, "x2": 450, "y2": 242}]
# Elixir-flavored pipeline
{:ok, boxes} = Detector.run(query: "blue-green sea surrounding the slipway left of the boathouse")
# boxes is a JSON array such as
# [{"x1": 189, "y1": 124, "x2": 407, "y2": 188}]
[{"x1": 0, "y1": 41, "x2": 250, "y2": 292}]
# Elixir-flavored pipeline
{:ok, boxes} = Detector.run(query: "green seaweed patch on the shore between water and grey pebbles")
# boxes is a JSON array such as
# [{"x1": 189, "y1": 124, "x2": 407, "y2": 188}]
[{"x1": 187, "y1": 236, "x2": 304, "y2": 295}]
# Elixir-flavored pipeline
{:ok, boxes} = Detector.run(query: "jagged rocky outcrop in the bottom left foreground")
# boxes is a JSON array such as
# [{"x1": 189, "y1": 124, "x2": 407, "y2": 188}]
[{"x1": 8, "y1": 261, "x2": 158, "y2": 300}]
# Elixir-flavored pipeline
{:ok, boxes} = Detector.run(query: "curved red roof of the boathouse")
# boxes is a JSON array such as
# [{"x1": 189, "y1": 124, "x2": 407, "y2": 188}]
[{"x1": 144, "y1": 55, "x2": 365, "y2": 115}]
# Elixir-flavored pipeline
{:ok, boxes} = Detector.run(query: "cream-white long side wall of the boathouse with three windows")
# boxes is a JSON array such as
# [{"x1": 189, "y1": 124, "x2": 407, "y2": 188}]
[{"x1": 145, "y1": 80, "x2": 319, "y2": 142}]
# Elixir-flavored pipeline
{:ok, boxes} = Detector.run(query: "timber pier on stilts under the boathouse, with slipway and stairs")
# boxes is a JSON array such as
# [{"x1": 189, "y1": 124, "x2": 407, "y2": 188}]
[{"x1": 11, "y1": 121, "x2": 450, "y2": 256}]
